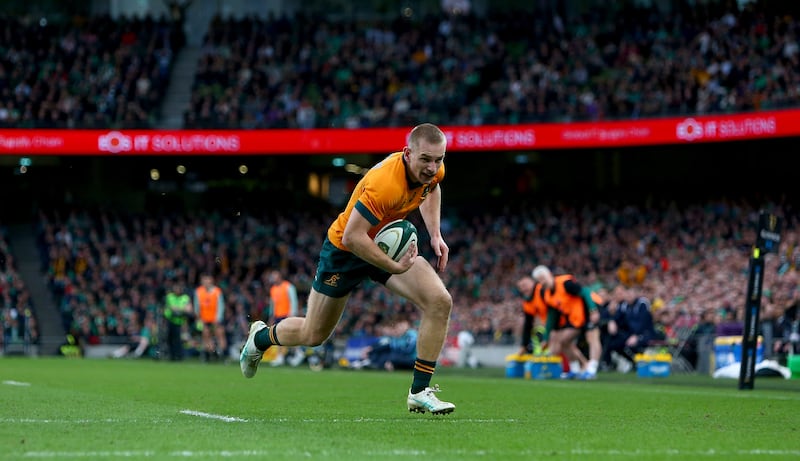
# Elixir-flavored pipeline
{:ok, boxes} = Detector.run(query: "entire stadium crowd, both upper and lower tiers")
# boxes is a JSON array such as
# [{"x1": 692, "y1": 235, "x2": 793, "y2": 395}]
[{"x1": 0, "y1": 2, "x2": 800, "y2": 366}]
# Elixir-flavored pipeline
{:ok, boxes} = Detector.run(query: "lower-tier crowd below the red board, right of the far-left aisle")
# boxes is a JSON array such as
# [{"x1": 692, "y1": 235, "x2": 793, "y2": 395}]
[{"x1": 40, "y1": 197, "x2": 800, "y2": 366}]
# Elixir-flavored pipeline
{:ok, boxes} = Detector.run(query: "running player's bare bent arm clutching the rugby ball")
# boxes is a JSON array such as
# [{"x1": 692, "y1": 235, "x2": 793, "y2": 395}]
[{"x1": 342, "y1": 208, "x2": 417, "y2": 274}]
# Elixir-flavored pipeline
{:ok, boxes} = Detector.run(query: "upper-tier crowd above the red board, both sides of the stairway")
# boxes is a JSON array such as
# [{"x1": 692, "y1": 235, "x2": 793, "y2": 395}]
[{"x1": 0, "y1": 2, "x2": 800, "y2": 129}]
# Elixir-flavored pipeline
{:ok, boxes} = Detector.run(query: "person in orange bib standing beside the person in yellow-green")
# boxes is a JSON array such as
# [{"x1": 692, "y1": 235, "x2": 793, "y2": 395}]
[{"x1": 194, "y1": 274, "x2": 228, "y2": 361}]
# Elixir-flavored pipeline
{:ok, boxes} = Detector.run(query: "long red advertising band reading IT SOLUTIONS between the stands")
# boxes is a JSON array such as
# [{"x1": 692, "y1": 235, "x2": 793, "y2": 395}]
[{"x1": 0, "y1": 110, "x2": 800, "y2": 155}]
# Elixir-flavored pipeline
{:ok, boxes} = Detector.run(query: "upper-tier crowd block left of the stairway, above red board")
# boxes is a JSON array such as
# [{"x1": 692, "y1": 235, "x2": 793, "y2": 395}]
[{"x1": 0, "y1": 15, "x2": 178, "y2": 128}]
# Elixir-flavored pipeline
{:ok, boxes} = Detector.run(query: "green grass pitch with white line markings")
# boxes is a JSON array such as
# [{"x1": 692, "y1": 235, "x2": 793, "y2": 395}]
[{"x1": 0, "y1": 358, "x2": 800, "y2": 461}]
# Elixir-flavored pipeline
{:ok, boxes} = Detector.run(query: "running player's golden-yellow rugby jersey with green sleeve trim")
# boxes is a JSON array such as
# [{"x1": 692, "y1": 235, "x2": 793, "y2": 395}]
[{"x1": 328, "y1": 152, "x2": 444, "y2": 251}]
